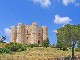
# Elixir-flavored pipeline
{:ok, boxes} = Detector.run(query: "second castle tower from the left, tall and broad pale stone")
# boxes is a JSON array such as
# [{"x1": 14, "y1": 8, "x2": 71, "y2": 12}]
[{"x1": 16, "y1": 23, "x2": 25, "y2": 43}]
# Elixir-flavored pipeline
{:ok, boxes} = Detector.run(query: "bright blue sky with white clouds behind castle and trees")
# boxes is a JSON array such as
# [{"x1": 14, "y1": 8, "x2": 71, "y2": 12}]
[{"x1": 0, "y1": 0, "x2": 80, "y2": 44}]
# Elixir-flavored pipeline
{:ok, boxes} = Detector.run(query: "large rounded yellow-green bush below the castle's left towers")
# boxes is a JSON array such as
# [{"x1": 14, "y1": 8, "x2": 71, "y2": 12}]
[{"x1": 5, "y1": 43, "x2": 27, "y2": 52}]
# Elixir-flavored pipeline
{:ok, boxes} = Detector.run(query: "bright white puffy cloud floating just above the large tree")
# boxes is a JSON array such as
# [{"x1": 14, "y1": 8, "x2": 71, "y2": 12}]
[{"x1": 54, "y1": 15, "x2": 72, "y2": 25}]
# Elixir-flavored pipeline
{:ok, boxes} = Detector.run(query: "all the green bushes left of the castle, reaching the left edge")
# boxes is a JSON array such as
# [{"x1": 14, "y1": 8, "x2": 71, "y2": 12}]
[{"x1": 0, "y1": 43, "x2": 27, "y2": 53}]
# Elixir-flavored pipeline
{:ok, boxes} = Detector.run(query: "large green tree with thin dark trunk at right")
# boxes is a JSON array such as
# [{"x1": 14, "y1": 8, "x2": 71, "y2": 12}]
[{"x1": 56, "y1": 24, "x2": 79, "y2": 60}]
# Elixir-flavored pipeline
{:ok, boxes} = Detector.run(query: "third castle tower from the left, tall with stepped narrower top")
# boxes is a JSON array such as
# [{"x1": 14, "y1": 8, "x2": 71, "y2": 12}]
[{"x1": 31, "y1": 22, "x2": 38, "y2": 44}]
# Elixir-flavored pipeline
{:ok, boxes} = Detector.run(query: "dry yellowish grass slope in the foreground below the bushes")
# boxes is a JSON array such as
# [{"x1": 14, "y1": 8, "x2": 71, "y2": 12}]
[{"x1": 0, "y1": 47, "x2": 80, "y2": 60}]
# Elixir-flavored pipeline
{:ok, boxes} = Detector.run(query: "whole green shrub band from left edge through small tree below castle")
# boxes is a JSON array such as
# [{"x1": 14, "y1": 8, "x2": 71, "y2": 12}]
[{"x1": 0, "y1": 39, "x2": 50, "y2": 53}]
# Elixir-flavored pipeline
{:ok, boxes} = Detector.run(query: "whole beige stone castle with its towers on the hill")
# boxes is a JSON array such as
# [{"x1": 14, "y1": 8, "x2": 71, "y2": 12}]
[{"x1": 11, "y1": 22, "x2": 48, "y2": 44}]
